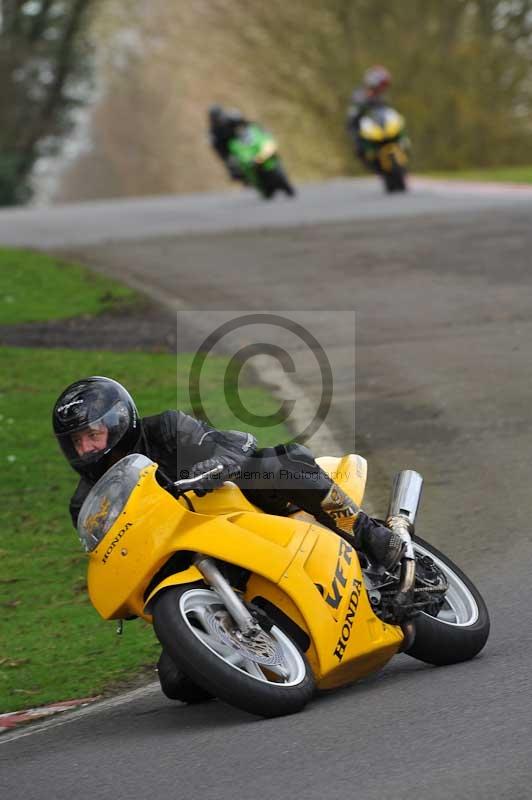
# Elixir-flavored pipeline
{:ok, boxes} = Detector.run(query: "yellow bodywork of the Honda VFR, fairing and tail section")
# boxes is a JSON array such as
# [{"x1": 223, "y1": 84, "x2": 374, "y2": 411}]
[{"x1": 88, "y1": 456, "x2": 403, "y2": 689}]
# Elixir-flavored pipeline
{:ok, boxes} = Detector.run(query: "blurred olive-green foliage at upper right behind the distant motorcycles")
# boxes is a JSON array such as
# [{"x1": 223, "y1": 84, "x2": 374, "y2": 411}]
[{"x1": 211, "y1": 0, "x2": 532, "y2": 174}]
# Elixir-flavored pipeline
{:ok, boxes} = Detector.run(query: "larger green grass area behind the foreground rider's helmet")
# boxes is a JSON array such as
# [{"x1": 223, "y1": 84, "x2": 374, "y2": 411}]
[{"x1": 0, "y1": 348, "x2": 288, "y2": 713}]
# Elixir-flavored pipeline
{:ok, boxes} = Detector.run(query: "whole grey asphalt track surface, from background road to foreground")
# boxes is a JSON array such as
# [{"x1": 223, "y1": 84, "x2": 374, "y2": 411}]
[{"x1": 0, "y1": 180, "x2": 532, "y2": 800}]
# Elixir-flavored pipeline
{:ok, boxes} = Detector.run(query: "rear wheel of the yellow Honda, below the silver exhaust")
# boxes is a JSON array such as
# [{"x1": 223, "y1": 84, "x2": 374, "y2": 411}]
[{"x1": 406, "y1": 536, "x2": 490, "y2": 666}]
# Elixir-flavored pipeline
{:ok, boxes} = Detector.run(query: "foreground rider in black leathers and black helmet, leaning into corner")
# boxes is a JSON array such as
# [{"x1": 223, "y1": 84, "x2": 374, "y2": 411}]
[{"x1": 52, "y1": 376, "x2": 403, "y2": 697}]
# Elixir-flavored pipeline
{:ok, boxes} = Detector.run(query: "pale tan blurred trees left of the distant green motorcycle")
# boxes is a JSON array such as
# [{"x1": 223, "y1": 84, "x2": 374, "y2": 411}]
[{"x1": 54, "y1": 0, "x2": 257, "y2": 202}]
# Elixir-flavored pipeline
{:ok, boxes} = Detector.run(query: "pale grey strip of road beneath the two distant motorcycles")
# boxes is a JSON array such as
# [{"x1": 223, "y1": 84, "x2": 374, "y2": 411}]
[{"x1": 0, "y1": 178, "x2": 532, "y2": 248}]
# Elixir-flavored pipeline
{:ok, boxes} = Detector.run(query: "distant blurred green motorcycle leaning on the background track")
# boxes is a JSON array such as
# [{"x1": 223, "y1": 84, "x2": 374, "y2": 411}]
[{"x1": 229, "y1": 123, "x2": 295, "y2": 199}]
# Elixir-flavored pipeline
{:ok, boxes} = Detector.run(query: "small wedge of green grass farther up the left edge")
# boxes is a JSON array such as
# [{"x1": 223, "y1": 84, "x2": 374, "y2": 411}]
[{"x1": 0, "y1": 248, "x2": 139, "y2": 325}]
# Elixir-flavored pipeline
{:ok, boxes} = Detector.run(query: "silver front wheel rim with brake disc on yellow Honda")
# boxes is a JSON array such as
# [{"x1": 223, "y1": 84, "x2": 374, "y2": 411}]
[{"x1": 179, "y1": 589, "x2": 306, "y2": 688}]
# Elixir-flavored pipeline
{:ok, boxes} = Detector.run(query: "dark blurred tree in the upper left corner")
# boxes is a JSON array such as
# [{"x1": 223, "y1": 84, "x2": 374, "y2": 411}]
[{"x1": 0, "y1": 0, "x2": 98, "y2": 206}]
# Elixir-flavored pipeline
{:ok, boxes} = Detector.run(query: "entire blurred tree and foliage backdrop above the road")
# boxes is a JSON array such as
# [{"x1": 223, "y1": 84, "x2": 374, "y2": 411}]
[{"x1": 0, "y1": 0, "x2": 532, "y2": 205}]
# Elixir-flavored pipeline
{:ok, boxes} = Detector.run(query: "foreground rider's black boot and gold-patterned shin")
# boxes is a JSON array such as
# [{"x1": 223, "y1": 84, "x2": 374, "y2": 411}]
[{"x1": 321, "y1": 483, "x2": 405, "y2": 571}]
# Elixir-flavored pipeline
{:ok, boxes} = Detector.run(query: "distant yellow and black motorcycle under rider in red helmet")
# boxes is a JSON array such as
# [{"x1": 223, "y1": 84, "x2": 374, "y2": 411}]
[{"x1": 357, "y1": 105, "x2": 410, "y2": 192}]
